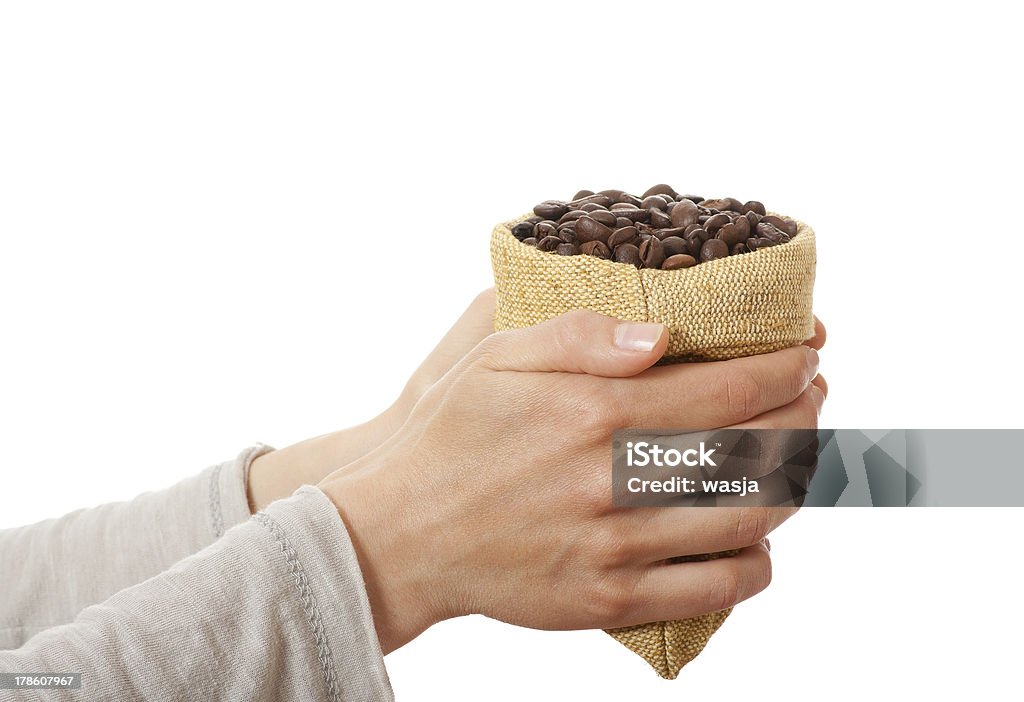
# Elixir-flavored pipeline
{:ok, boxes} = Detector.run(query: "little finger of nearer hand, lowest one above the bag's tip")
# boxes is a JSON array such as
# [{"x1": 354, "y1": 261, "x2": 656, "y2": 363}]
[{"x1": 615, "y1": 542, "x2": 771, "y2": 626}]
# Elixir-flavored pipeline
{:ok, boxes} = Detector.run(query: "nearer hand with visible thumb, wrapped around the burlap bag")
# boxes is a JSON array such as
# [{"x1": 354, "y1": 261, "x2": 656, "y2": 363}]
[{"x1": 321, "y1": 312, "x2": 824, "y2": 652}]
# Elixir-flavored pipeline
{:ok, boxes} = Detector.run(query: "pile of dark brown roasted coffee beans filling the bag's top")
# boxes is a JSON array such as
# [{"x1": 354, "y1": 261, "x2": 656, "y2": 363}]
[{"x1": 512, "y1": 183, "x2": 797, "y2": 270}]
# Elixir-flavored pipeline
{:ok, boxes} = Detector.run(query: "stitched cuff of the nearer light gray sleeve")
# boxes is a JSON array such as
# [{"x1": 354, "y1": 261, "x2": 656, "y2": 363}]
[{"x1": 253, "y1": 485, "x2": 394, "y2": 700}]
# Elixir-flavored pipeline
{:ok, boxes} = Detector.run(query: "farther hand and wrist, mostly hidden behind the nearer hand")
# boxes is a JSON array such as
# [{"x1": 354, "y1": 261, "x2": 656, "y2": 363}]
[{"x1": 246, "y1": 289, "x2": 495, "y2": 513}]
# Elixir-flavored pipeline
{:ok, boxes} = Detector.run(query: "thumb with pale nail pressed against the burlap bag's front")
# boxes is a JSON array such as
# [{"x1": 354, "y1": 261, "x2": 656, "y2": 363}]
[{"x1": 477, "y1": 310, "x2": 669, "y2": 378}]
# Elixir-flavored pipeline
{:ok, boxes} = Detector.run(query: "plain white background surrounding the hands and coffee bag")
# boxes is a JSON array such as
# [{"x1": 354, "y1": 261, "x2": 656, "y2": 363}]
[{"x1": 0, "y1": 0, "x2": 1024, "y2": 700}]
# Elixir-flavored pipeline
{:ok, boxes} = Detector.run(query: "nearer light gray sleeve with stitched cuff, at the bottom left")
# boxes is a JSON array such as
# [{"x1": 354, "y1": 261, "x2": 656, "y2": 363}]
[{"x1": 0, "y1": 486, "x2": 393, "y2": 702}]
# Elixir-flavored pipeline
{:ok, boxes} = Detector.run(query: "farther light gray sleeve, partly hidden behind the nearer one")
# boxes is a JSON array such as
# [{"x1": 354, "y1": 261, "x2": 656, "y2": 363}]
[{"x1": 0, "y1": 444, "x2": 273, "y2": 650}]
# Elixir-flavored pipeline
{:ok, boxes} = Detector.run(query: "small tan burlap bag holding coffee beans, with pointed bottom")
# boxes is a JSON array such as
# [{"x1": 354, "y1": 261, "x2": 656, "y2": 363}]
[{"x1": 490, "y1": 215, "x2": 815, "y2": 679}]
